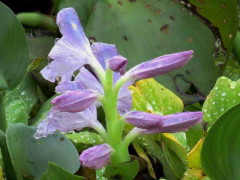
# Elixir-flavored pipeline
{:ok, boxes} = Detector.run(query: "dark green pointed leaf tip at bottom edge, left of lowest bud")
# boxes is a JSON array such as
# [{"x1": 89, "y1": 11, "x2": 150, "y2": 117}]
[{"x1": 41, "y1": 162, "x2": 84, "y2": 180}]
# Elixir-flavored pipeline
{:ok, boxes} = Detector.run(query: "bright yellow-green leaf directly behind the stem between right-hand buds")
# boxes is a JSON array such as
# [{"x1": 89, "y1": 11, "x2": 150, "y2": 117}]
[{"x1": 129, "y1": 79, "x2": 183, "y2": 115}]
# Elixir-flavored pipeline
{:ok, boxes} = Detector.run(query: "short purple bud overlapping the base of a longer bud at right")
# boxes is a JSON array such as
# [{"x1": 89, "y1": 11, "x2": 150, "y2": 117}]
[{"x1": 126, "y1": 111, "x2": 163, "y2": 129}]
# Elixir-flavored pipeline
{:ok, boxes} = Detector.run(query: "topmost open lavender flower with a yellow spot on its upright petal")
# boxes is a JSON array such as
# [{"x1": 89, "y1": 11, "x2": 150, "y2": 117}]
[{"x1": 41, "y1": 8, "x2": 94, "y2": 82}]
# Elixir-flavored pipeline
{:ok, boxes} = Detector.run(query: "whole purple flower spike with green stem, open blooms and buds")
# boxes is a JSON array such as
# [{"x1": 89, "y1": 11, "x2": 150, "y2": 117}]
[{"x1": 35, "y1": 8, "x2": 202, "y2": 169}]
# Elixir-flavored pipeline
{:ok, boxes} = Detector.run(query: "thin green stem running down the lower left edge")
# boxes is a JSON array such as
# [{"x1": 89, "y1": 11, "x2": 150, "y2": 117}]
[{"x1": 0, "y1": 92, "x2": 17, "y2": 180}]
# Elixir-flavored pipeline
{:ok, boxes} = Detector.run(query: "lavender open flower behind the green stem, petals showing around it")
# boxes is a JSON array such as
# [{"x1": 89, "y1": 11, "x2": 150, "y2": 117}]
[{"x1": 56, "y1": 43, "x2": 133, "y2": 115}]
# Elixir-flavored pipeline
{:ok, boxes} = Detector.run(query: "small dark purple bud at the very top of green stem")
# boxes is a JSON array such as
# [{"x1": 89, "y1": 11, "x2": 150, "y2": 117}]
[{"x1": 108, "y1": 56, "x2": 128, "y2": 75}]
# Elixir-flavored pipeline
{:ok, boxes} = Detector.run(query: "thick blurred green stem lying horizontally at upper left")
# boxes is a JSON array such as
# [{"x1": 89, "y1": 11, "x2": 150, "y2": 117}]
[{"x1": 17, "y1": 12, "x2": 58, "y2": 33}]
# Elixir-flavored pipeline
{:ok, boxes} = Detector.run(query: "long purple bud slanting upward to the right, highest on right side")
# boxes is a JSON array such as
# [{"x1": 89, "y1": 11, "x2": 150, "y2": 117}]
[{"x1": 126, "y1": 50, "x2": 193, "y2": 79}]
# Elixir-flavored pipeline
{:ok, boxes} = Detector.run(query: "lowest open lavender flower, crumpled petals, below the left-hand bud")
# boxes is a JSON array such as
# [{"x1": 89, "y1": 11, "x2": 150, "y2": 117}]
[{"x1": 34, "y1": 105, "x2": 103, "y2": 139}]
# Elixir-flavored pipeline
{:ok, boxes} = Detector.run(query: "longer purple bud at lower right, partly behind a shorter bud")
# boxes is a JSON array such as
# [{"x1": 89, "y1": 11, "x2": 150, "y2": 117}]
[{"x1": 141, "y1": 111, "x2": 203, "y2": 134}]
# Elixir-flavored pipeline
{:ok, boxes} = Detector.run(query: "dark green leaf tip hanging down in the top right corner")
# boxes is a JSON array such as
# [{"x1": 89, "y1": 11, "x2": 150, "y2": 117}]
[{"x1": 189, "y1": 0, "x2": 238, "y2": 48}]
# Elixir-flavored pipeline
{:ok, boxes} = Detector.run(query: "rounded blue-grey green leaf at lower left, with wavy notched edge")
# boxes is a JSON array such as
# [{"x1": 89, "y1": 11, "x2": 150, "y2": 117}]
[{"x1": 6, "y1": 124, "x2": 80, "y2": 179}]
